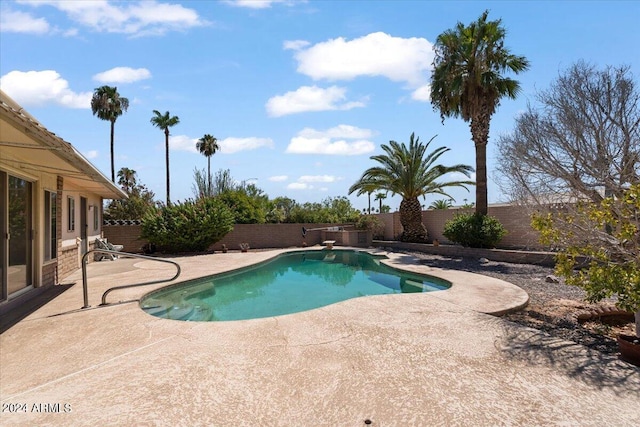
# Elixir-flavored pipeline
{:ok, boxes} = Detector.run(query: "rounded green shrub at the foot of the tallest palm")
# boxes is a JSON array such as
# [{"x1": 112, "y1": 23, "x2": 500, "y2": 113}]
[{"x1": 443, "y1": 213, "x2": 507, "y2": 248}]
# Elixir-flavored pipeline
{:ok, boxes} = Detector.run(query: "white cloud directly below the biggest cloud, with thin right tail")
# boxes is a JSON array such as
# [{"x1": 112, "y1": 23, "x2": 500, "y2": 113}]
[{"x1": 265, "y1": 86, "x2": 365, "y2": 117}]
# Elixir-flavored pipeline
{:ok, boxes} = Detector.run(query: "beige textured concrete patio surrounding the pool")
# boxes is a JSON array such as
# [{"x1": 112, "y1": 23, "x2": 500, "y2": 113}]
[{"x1": 0, "y1": 250, "x2": 640, "y2": 427}]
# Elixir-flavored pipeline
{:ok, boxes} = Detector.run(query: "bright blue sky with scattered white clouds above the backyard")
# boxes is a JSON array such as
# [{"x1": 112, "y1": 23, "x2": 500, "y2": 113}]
[{"x1": 0, "y1": 0, "x2": 640, "y2": 210}]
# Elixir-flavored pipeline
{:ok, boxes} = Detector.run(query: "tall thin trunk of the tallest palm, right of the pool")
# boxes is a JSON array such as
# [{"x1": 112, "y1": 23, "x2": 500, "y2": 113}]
[{"x1": 469, "y1": 105, "x2": 491, "y2": 215}]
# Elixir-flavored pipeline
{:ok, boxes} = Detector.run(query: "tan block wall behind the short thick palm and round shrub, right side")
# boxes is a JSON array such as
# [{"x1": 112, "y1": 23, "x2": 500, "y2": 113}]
[{"x1": 377, "y1": 205, "x2": 542, "y2": 249}]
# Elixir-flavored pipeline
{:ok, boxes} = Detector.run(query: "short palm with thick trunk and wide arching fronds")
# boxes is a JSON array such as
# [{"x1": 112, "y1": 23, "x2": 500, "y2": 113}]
[{"x1": 349, "y1": 133, "x2": 474, "y2": 242}]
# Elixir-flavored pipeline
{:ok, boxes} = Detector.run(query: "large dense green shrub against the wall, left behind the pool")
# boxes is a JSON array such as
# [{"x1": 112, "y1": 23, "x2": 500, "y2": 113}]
[{"x1": 141, "y1": 198, "x2": 234, "y2": 253}]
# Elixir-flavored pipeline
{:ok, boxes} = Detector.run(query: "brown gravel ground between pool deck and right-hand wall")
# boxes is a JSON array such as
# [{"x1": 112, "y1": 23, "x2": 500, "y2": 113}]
[{"x1": 402, "y1": 251, "x2": 635, "y2": 354}]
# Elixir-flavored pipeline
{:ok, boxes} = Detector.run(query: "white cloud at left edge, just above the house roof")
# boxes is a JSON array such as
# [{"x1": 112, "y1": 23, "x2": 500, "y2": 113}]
[{"x1": 0, "y1": 70, "x2": 93, "y2": 108}]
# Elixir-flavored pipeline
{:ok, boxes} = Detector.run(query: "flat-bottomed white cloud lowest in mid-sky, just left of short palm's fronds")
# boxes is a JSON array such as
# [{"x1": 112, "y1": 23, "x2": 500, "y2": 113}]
[{"x1": 285, "y1": 125, "x2": 375, "y2": 156}]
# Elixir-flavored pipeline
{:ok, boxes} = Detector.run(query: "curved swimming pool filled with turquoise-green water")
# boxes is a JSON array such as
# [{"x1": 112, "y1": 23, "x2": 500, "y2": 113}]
[{"x1": 140, "y1": 250, "x2": 451, "y2": 321}]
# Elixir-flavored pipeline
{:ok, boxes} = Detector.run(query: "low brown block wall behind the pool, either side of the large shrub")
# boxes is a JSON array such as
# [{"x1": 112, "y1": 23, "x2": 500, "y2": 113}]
[{"x1": 102, "y1": 224, "x2": 371, "y2": 253}]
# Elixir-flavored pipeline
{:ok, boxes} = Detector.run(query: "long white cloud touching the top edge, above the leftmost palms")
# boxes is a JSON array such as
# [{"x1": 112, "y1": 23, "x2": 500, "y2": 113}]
[{"x1": 21, "y1": 0, "x2": 208, "y2": 36}]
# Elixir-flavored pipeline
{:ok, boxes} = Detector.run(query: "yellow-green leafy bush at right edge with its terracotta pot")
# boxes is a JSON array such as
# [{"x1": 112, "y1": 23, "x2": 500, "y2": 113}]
[{"x1": 532, "y1": 184, "x2": 640, "y2": 366}]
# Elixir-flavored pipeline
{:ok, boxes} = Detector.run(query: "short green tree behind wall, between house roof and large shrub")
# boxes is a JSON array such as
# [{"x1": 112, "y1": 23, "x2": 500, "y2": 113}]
[{"x1": 104, "y1": 168, "x2": 155, "y2": 220}]
